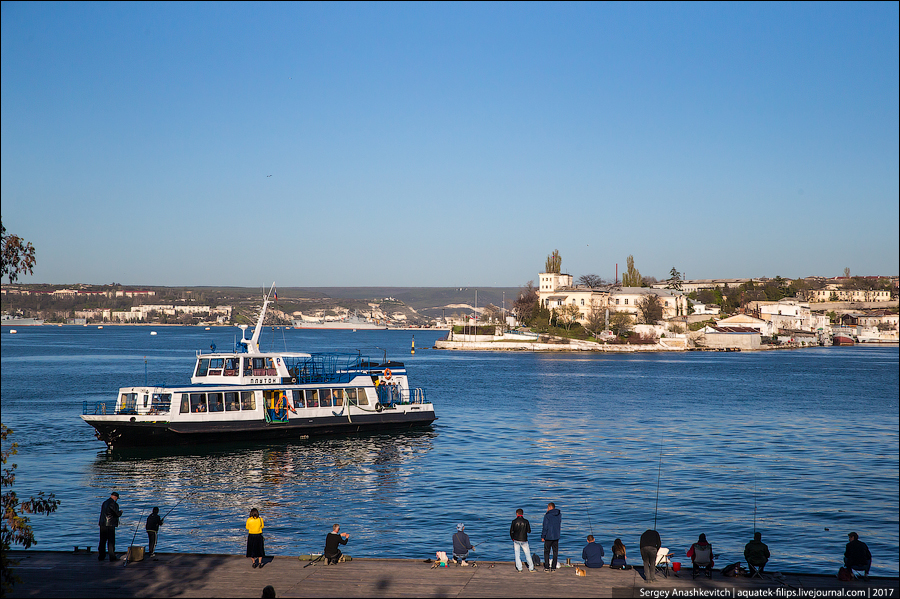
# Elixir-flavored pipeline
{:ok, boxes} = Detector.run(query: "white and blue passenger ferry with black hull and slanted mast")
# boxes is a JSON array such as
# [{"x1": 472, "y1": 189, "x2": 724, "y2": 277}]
[{"x1": 81, "y1": 286, "x2": 436, "y2": 449}]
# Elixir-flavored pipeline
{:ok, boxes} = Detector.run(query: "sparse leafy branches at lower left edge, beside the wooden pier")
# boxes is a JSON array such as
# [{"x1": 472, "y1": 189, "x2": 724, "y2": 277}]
[{"x1": 0, "y1": 424, "x2": 59, "y2": 594}]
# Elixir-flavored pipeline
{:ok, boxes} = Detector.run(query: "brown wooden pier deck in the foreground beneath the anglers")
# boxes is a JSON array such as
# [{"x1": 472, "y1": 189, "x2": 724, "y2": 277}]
[{"x1": 9, "y1": 550, "x2": 898, "y2": 598}]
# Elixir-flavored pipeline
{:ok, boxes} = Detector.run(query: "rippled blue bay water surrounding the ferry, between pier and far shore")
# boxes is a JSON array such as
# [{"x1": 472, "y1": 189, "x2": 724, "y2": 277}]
[{"x1": 2, "y1": 327, "x2": 900, "y2": 576}]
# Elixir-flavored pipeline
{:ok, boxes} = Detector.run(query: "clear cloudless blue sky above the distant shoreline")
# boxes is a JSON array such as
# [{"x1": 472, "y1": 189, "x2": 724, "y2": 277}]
[{"x1": 0, "y1": 2, "x2": 900, "y2": 286}]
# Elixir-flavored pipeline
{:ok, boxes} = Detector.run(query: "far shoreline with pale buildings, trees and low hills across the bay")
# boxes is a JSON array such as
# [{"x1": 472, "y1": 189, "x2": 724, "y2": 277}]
[{"x1": 0, "y1": 252, "x2": 898, "y2": 350}]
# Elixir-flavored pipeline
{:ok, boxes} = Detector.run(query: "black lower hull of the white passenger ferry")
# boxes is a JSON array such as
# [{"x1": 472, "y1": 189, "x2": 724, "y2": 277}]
[{"x1": 85, "y1": 409, "x2": 436, "y2": 449}]
